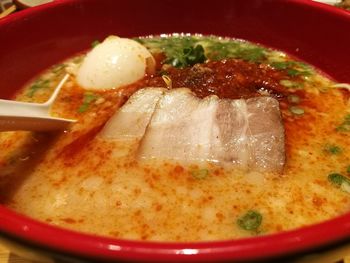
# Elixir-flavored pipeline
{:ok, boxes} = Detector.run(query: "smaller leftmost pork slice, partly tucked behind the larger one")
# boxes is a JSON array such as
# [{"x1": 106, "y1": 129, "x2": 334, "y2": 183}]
[{"x1": 100, "y1": 87, "x2": 166, "y2": 140}]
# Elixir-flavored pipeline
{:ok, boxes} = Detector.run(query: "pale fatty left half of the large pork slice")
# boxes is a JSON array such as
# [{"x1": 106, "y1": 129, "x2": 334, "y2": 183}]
[{"x1": 139, "y1": 88, "x2": 219, "y2": 162}]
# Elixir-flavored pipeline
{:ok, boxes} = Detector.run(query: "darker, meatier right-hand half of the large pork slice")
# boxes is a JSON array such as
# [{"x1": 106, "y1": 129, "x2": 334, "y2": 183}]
[{"x1": 212, "y1": 97, "x2": 285, "y2": 172}]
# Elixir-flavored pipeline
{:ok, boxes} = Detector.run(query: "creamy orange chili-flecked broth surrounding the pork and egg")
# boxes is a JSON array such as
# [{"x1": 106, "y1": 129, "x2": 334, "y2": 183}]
[{"x1": 0, "y1": 37, "x2": 350, "y2": 241}]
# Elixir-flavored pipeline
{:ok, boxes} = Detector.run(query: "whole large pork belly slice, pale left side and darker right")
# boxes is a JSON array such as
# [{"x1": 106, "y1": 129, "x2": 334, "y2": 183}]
[{"x1": 138, "y1": 88, "x2": 285, "y2": 172}]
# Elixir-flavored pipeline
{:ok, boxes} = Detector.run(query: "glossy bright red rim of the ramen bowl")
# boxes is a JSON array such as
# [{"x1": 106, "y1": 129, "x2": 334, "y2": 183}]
[{"x1": 0, "y1": 0, "x2": 350, "y2": 262}]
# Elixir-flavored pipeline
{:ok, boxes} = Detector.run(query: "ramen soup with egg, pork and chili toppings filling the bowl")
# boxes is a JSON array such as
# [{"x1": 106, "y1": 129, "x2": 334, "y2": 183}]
[{"x1": 0, "y1": 35, "x2": 350, "y2": 241}]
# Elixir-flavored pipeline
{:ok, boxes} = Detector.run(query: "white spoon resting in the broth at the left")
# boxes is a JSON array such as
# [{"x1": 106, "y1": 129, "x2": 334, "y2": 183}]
[{"x1": 0, "y1": 74, "x2": 76, "y2": 131}]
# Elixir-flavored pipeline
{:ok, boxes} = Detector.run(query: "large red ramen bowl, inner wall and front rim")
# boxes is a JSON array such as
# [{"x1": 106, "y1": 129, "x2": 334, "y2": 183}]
[{"x1": 0, "y1": 0, "x2": 350, "y2": 262}]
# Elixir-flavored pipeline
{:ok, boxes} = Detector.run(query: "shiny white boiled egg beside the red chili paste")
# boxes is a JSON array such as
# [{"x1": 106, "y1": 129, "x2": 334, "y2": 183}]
[{"x1": 77, "y1": 36, "x2": 155, "y2": 90}]
